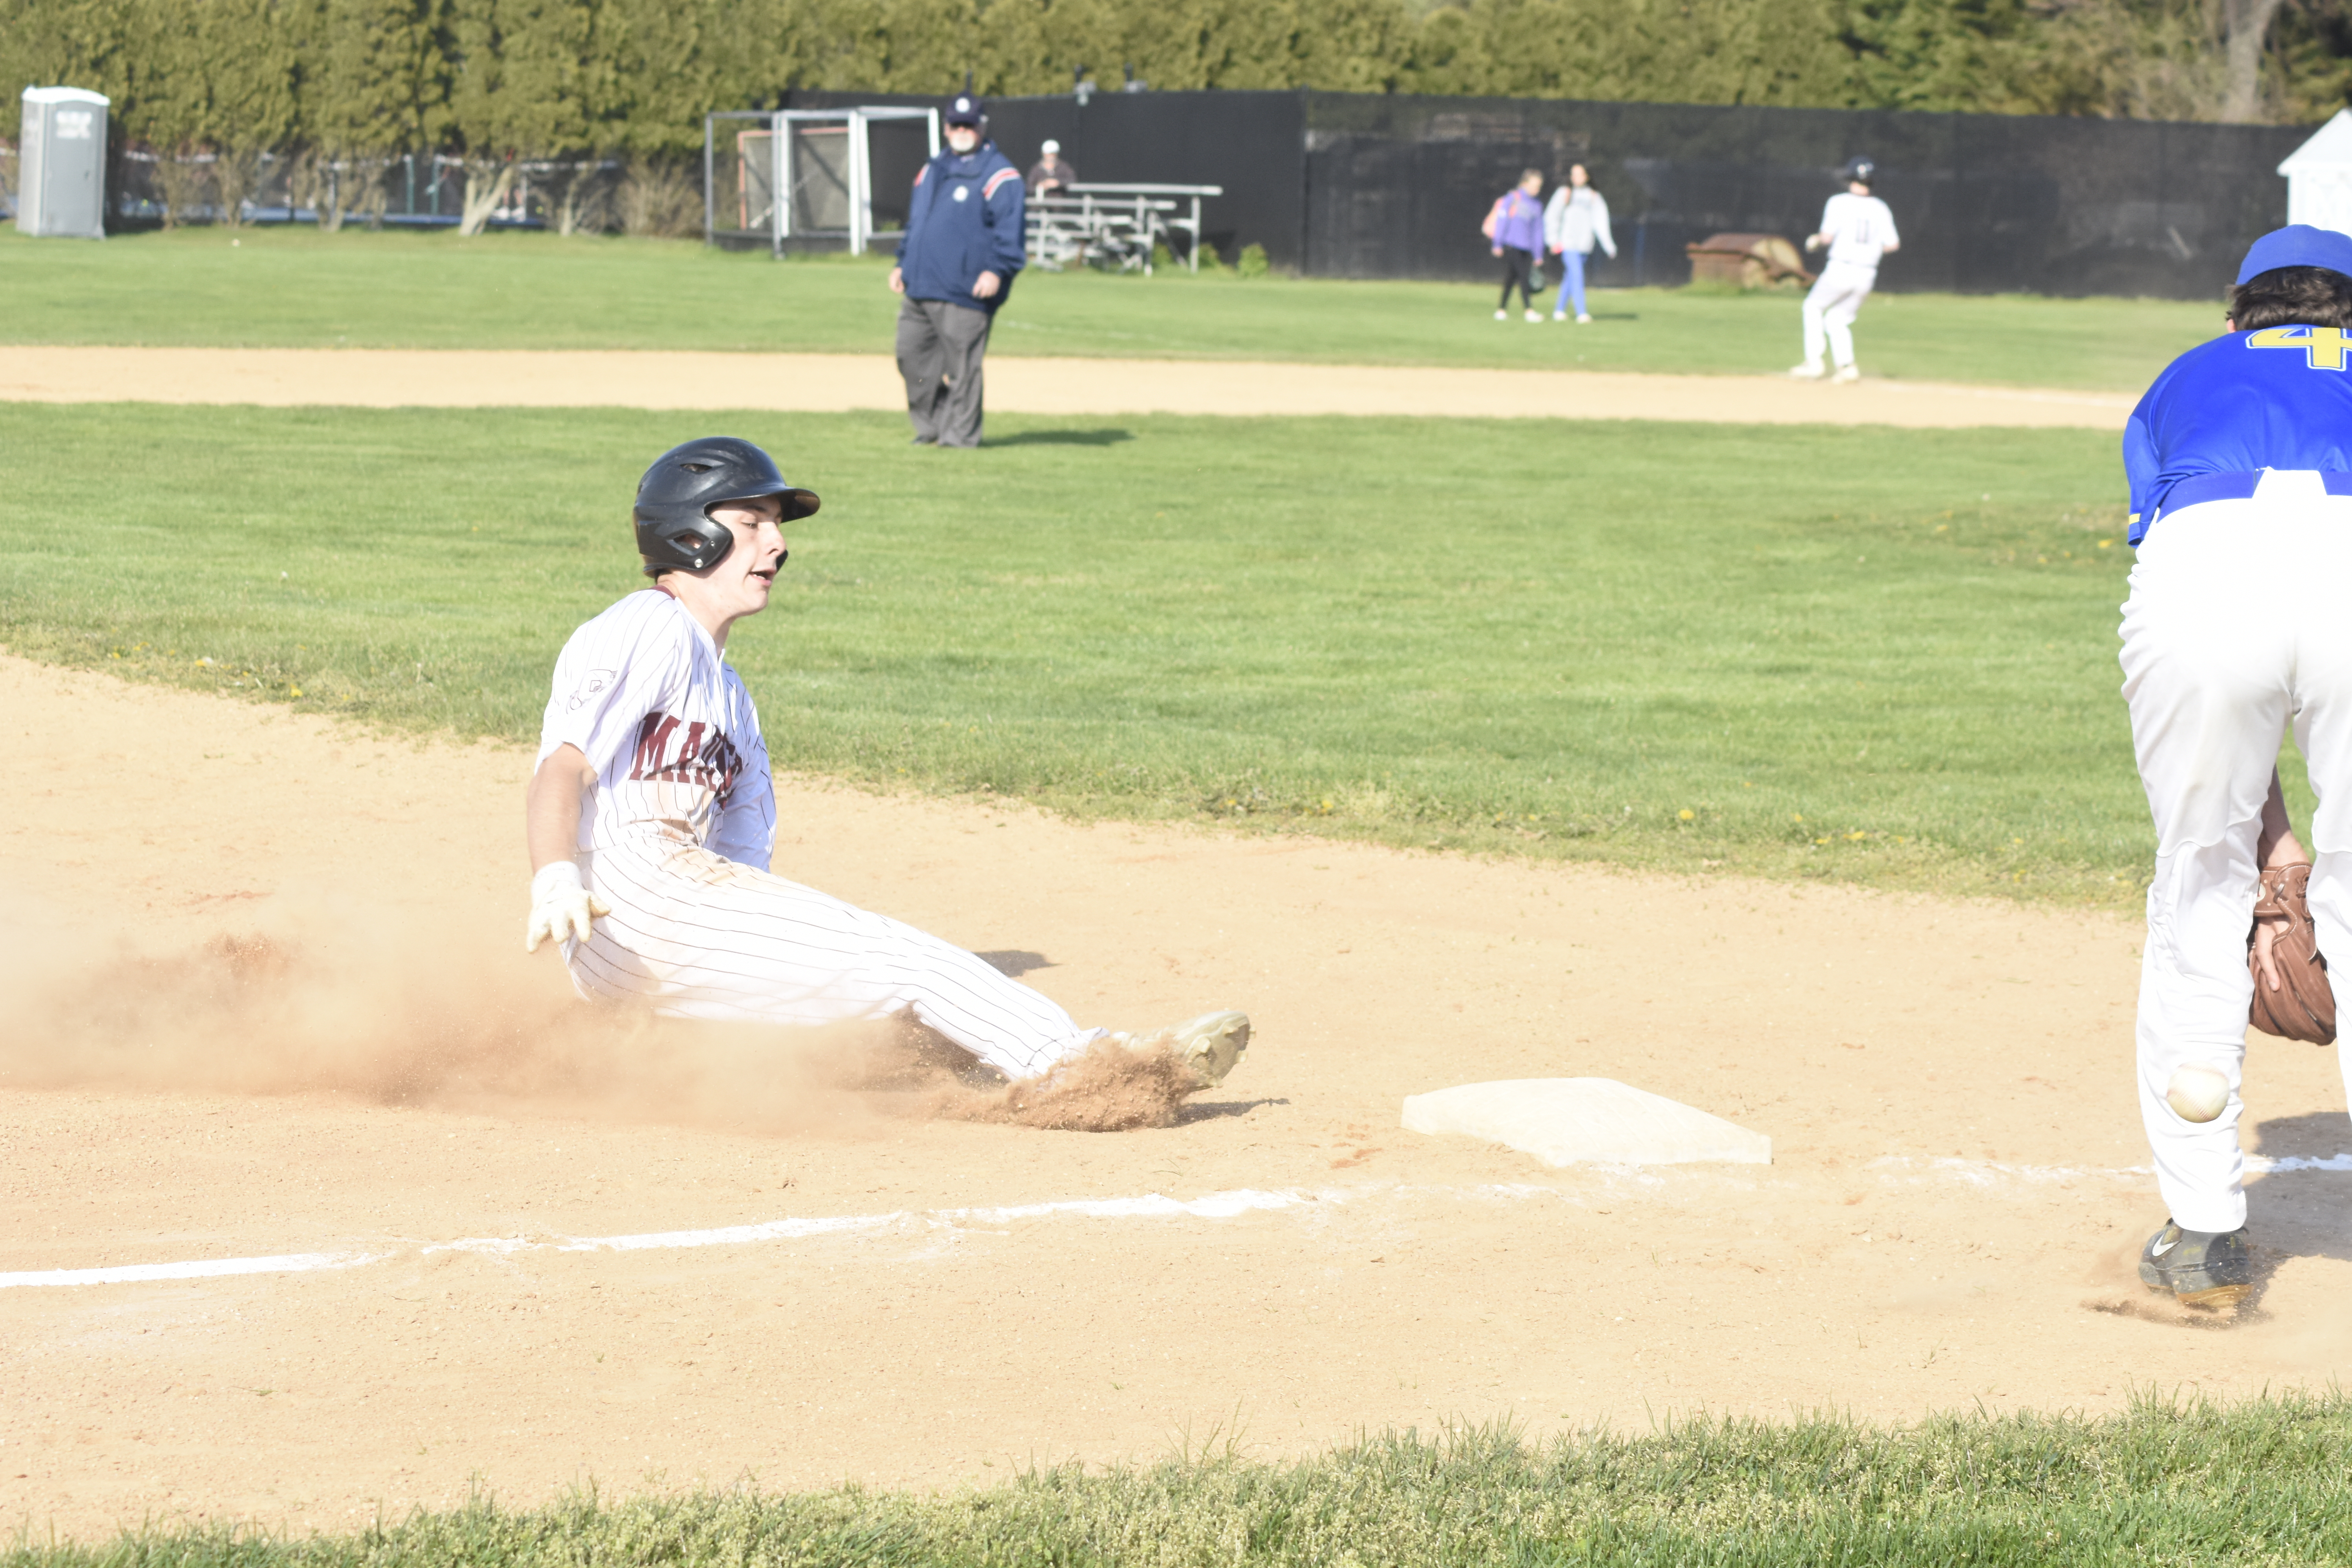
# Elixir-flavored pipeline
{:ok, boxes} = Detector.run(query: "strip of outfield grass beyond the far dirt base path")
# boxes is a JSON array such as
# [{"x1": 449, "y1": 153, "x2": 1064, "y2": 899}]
[{"x1": 0, "y1": 226, "x2": 2220, "y2": 392}]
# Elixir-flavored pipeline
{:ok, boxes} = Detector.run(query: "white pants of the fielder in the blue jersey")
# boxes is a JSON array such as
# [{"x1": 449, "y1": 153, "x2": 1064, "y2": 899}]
[{"x1": 2122, "y1": 470, "x2": 2352, "y2": 1232}]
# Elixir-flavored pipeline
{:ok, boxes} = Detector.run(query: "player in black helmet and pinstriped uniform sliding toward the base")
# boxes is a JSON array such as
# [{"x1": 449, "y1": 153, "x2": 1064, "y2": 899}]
[{"x1": 524, "y1": 437, "x2": 1249, "y2": 1105}]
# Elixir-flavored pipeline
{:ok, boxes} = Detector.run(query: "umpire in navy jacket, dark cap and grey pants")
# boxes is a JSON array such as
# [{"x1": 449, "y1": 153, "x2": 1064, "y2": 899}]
[{"x1": 889, "y1": 92, "x2": 1028, "y2": 446}]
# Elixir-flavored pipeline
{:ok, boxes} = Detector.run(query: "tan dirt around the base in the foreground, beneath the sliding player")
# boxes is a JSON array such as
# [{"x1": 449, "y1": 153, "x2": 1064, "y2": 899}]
[{"x1": 0, "y1": 658, "x2": 2352, "y2": 1535}]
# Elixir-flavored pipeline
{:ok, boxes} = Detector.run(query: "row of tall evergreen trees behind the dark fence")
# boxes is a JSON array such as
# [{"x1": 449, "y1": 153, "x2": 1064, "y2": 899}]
[{"x1": 0, "y1": 0, "x2": 2352, "y2": 228}]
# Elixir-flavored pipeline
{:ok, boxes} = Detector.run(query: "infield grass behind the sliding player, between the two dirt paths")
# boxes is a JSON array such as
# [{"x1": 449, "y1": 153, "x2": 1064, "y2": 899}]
[{"x1": 0, "y1": 404, "x2": 2300, "y2": 905}]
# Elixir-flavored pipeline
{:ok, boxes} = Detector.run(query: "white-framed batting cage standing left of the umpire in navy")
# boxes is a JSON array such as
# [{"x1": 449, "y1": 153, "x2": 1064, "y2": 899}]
[{"x1": 703, "y1": 103, "x2": 938, "y2": 259}]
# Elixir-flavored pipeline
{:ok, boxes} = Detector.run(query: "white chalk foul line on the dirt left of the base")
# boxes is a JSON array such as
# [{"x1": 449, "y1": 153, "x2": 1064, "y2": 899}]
[{"x1": 0, "y1": 1187, "x2": 1345, "y2": 1290}]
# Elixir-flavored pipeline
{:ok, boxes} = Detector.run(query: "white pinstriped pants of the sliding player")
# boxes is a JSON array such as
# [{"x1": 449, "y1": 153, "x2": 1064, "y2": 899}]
[{"x1": 564, "y1": 846, "x2": 1105, "y2": 1079}]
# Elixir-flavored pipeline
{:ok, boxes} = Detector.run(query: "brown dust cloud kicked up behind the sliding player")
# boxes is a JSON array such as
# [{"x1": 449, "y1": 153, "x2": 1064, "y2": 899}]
[{"x1": 0, "y1": 907, "x2": 976, "y2": 1133}]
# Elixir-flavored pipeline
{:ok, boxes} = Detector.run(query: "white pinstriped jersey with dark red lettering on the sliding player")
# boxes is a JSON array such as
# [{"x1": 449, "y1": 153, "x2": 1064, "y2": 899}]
[{"x1": 539, "y1": 588, "x2": 776, "y2": 872}]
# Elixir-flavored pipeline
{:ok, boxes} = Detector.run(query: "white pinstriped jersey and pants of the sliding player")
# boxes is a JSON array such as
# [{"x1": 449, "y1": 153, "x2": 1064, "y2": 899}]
[{"x1": 539, "y1": 588, "x2": 1105, "y2": 1079}]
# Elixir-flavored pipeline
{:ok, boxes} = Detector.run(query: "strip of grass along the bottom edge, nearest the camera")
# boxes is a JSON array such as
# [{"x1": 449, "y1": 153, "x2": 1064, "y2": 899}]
[{"x1": 0, "y1": 1394, "x2": 2352, "y2": 1568}]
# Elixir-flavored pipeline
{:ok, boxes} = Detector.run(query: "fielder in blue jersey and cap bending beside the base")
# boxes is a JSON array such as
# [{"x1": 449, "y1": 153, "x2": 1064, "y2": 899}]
[{"x1": 2122, "y1": 226, "x2": 2352, "y2": 1305}]
